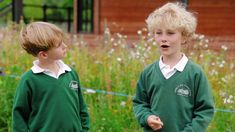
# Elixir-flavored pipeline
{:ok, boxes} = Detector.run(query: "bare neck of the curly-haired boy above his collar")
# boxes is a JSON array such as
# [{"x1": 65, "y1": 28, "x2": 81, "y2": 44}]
[{"x1": 162, "y1": 53, "x2": 183, "y2": 68}]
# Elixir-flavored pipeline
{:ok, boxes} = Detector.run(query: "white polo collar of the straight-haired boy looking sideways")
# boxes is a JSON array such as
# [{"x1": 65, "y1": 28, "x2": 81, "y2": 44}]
[{"x1": 31, "y1": 60, "x2": 71, "y2": 79}]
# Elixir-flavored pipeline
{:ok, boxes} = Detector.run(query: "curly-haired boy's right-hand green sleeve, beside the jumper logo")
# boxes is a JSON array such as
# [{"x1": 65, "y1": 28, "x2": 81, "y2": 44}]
[{"x1": 184, "y1": 71, "x2": 215, "y2": 132}]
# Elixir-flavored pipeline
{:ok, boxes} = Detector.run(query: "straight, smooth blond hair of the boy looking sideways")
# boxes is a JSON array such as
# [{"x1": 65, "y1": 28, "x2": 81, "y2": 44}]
[{"x1": 20, "y1": 22, "x2": 65, "y2": 56}]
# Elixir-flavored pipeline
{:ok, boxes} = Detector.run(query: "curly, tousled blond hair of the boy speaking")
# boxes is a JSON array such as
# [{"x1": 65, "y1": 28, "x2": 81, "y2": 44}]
[{"x1": 146, "y1": 2, "x2": 197, "y2": 38}]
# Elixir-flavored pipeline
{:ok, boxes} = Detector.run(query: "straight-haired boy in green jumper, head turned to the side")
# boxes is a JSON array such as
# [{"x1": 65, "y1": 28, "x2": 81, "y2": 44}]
[{"x1": 13, "y1": 22, "x2": 89, "y2": 132}]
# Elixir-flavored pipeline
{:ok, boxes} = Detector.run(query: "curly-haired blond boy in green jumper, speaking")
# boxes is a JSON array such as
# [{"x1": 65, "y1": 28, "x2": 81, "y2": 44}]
[{"x1": 133, "y1": 3, "x2": 214, "y2": 132}]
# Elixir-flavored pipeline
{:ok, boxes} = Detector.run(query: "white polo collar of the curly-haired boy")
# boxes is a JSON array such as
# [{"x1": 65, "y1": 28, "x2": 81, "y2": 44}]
[{"x1": 159, "y1": 54, "x2": 188, "y2": 79}]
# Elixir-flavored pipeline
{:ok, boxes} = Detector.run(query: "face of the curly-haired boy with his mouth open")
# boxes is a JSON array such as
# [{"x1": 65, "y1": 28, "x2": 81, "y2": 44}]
[{"x1": 155, "y1": 28, "x2": 184, "y2": 56}]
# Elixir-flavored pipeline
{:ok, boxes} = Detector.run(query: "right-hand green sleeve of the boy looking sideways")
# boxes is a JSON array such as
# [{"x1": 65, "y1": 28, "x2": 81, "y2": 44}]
[{"x1": 78, "y1": 75, "x2": 90, "y2": 132}]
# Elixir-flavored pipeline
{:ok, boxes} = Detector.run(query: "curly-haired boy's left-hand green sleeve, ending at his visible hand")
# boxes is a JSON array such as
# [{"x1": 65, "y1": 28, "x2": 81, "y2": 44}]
[{"x1": 133, "y1": 73, "x2": 152, "y2": 127}]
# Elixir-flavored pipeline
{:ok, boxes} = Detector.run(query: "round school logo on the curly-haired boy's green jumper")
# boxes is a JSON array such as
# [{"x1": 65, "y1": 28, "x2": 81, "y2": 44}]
[{"x1": 175, "y1": 84, "x2": 191, "y2": 97}]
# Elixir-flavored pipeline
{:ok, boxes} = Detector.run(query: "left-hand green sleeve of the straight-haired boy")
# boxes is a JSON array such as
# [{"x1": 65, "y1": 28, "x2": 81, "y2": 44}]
[{"x1": 12, "y1": 79, "x2": 31, "y2": 132}]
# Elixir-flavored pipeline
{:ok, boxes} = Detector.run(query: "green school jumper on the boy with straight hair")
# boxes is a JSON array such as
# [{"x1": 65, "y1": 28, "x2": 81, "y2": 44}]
[{"x1": 13, "y1": 69, "x2": 89, "y2": 132}]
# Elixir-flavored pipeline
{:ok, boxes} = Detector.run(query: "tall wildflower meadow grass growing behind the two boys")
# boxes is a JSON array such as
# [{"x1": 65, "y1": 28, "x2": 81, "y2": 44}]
[{"x1": 0, "y1": 24, "x2": 235, "y2": 132}]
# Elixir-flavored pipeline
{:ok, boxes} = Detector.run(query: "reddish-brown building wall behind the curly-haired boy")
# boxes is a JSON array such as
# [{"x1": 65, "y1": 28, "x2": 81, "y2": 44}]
[{"x1": 96, "y1": 0, "x2": 235, "y2": 36}]
